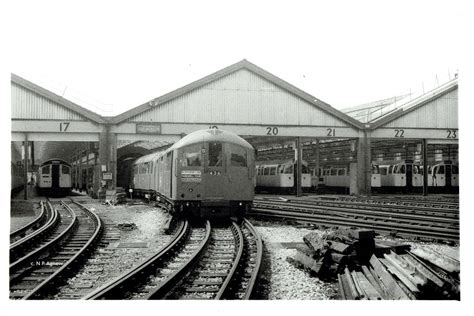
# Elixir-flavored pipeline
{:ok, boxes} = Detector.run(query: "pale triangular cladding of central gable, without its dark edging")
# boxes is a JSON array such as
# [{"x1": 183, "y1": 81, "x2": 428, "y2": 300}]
[{"x1": 129, "y1": 69, "x2": 347, "y2": 126}]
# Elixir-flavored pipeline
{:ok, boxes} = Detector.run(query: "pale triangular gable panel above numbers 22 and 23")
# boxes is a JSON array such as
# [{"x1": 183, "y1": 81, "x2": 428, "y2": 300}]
[{"x1": 384, "y1": 89, "x2": 458, "y2": 129}]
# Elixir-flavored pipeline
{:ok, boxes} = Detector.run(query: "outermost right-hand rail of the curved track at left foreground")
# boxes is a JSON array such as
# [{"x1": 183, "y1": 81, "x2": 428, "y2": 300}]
[{"x1": 23, "y1": 201, "x2": 103, "y2": 300}]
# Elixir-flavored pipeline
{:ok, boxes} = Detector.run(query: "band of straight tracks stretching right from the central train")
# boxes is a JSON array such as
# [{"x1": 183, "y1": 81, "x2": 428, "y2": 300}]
[{"x1": 249, "y1": 199, "x2": 459, "y2": 241}]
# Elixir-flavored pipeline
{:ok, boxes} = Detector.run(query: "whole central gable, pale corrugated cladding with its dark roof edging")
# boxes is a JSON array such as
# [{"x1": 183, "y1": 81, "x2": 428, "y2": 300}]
[{"x1": 111, "y1": 59, "x2": 362, "y2": 128}]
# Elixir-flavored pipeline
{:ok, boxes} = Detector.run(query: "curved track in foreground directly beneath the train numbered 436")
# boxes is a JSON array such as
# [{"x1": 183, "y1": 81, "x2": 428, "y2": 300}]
[{"x1": 86, "y1": 221, "x2": 262, "y2": 299}]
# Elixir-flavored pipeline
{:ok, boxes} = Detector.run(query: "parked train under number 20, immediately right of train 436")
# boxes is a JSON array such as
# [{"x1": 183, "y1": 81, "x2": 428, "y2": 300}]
[{"x1": 255, "y1": 159, "x2": 311, "y2": 192}]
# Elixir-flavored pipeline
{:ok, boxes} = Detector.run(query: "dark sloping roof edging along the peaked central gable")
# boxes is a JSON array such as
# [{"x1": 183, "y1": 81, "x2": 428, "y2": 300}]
[{"x1": 110, "y1": 59, "x2": 363, "y2": 128}]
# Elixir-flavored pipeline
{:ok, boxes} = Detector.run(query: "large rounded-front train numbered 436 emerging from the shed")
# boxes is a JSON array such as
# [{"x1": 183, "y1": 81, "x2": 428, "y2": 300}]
[{"x1": 131, "y1": 129, "x2": 255, "y2": 218}]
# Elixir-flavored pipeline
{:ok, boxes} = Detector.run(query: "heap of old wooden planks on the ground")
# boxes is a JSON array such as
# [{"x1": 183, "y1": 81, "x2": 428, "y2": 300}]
[{"x1": 287, "y1": 229, "x2": 459, "y2": 300}]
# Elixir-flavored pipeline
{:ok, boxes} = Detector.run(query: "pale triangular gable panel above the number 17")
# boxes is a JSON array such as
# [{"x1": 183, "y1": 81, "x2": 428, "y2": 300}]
[{"x1": 11, "y1": 83, "x2": 84, "y2": 121}]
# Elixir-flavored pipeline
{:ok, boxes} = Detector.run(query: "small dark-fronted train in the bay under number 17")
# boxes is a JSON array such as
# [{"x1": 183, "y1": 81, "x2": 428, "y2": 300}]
[{"x1": 36, "y1": 159, "x2": 72, "y2": 196}]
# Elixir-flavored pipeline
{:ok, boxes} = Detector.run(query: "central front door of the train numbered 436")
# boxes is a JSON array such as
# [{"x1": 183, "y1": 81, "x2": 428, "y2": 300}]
[{"x1": 203, "y1": 142, "x2": 226, "y2": 200}]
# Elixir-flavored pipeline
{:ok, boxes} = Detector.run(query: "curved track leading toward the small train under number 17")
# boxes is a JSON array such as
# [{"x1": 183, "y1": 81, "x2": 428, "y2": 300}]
[{"x1": 10, "y1": 202, "x2": 102, "y2": 299}]
